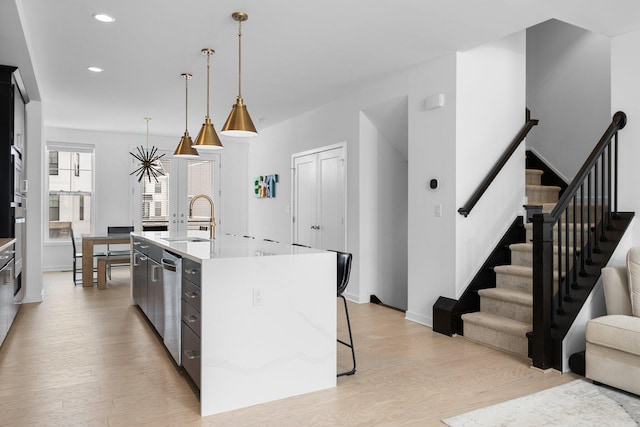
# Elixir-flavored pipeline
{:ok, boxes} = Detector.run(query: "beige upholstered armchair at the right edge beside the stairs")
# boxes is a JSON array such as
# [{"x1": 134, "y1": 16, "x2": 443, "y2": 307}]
[{"x1": 585, "y1": 248, "x2": 640, "y2": 395}]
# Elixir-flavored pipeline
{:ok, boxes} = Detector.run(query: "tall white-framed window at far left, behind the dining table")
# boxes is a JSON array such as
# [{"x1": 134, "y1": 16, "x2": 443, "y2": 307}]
[{"x1": 47, "y1": 143, "x2": 94, "y2": 241}]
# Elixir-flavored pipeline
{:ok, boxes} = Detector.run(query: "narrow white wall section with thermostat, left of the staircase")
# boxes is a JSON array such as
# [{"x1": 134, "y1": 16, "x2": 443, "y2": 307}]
[{"x1": 406, "y1": 54, "x2": 458, "y2": 325}]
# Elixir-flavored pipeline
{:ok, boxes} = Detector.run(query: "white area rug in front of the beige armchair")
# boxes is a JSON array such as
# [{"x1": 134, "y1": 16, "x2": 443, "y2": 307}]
[{"x1": 442, "y1": 380, "x2": 640, "y2": 427}]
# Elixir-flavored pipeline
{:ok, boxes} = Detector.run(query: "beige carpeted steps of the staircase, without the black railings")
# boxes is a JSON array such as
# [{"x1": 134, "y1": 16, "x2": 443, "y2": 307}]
[{"x1": 462, "y1": 169, "x2": 560, "y2": 357}]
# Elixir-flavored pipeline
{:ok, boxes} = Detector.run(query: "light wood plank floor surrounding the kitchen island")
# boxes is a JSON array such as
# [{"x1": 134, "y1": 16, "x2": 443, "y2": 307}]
[{"x1": 0, "y1": 268, "x2": 575, "y2": 426}]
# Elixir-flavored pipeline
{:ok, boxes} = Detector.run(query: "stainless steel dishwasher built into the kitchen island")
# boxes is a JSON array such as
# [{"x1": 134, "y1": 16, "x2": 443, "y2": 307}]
[{"x1": 162, "y1": 251, "x2": 182, "y2": 365}]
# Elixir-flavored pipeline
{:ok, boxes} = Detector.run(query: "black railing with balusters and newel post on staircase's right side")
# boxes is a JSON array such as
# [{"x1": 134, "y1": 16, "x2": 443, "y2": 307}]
[{"x1": 531, "y1": 111, "x2": 630, "y2": 369}]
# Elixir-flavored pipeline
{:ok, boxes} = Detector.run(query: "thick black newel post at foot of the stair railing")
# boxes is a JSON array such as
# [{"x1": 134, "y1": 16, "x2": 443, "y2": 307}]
[{"x1": 532, "y1": 214, "x2": 555, "y2": 369}]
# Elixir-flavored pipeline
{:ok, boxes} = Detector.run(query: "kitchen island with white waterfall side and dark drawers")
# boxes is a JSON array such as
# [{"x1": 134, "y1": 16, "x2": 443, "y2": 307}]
[{"x1": 131, "y1": 232, "x2": 336, "y2": 416}]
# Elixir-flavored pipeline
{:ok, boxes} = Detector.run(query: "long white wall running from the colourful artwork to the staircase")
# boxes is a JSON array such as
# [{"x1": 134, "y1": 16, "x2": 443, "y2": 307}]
[{"x1": 249, "y1": 33, "x2": 525, "y2": 325}]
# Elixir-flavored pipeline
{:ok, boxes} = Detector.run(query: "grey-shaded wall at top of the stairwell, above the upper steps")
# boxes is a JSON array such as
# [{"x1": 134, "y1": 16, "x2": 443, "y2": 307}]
[{"x1": 527, "y1": 19, "x2": 612, "y2": 182}]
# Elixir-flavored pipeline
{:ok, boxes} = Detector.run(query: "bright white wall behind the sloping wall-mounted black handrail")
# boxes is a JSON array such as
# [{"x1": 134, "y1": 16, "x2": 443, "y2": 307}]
[{"x1": 456, "y1": 31, "x2": 526, "y2": 302}]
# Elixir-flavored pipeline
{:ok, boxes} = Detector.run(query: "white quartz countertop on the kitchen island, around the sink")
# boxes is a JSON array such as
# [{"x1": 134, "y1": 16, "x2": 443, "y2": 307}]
[{"x1": 131, "y1": 231, "x2": 326, "y2": 261}]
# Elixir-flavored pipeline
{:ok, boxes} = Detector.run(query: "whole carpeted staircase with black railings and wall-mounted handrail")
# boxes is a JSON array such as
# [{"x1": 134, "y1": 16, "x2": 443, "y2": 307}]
[{"x1": 440, "y1": 111, "x2": 635, "y2": 370}]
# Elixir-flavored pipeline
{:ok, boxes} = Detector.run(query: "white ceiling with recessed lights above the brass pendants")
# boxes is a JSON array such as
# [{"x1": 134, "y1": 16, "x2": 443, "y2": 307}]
[{"x1": 0, "y1": 0, "x2": 640, "y2": 140}]
